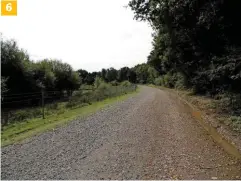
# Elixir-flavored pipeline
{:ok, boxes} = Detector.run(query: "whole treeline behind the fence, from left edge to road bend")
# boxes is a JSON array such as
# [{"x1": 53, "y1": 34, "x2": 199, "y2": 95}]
[{"x1": 1, "y1": 40, "x2": 158, "y2": 108}]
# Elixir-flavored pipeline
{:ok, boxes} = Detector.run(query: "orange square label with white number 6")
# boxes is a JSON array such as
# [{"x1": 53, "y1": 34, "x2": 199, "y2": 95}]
[{"x1": 1, "y1": 0, "x2": 17, "y2": 16}]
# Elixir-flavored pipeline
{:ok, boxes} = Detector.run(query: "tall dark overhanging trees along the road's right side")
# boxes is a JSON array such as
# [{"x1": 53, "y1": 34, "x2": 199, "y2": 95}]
[{"x1": 129, "y1": 0, "x2": 241, "y2": 95}]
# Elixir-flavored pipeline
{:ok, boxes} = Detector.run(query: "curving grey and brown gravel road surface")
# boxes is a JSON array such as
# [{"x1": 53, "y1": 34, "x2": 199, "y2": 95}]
[{"x1": 1, "y1": 87, "x2": 241, "y2": 180}]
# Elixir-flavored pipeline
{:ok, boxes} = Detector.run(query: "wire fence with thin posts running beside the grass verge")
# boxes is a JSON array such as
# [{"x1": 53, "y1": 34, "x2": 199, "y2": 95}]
[{"x1": 1, "y1": 85, "x2": 136, "y2": 125}]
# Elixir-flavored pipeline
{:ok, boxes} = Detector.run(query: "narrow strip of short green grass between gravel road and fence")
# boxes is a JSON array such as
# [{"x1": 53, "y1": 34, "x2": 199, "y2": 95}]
[{"x1": 1, "y1": 89, "x2": 139, "y2": 146}]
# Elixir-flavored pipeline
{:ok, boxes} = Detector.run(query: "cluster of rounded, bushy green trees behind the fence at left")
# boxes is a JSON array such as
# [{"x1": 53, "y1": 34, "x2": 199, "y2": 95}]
[{"x1": 1, "y1": 40, "x2": 81, "y2": 101}]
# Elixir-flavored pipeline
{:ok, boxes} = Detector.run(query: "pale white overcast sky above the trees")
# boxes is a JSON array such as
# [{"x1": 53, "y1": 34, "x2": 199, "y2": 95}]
[{"x1": 0, "y1": 0, "x2": 152, "y2": 71}]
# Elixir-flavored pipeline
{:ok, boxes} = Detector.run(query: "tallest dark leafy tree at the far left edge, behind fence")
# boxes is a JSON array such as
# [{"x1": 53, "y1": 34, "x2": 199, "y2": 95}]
[{"x1": 1, "y1": 40, "x2": 36, "y2": 94}]
